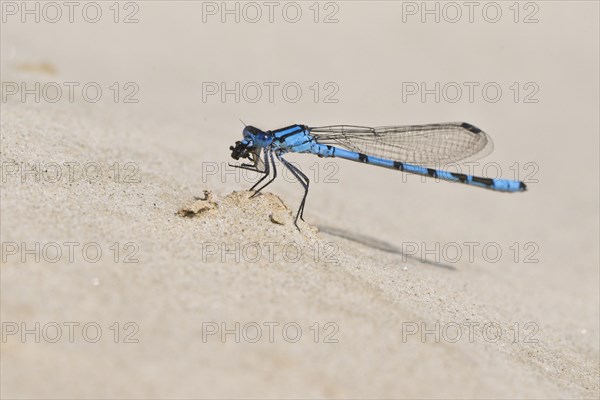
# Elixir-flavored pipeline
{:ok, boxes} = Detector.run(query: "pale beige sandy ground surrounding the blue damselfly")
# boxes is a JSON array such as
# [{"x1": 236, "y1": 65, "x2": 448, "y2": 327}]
[{"x1": 0, "y1": 2, "x2": 600, "y2": 399}]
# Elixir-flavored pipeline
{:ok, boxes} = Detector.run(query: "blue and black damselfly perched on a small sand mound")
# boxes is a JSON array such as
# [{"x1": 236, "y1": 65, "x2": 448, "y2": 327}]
[{"x1": 229, "y1": 122, "x2": 526, "y2": 227}]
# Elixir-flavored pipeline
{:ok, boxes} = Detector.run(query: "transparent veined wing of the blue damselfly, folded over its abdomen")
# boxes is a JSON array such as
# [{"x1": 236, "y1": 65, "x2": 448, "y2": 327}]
[{"x1": 309, "y1": 122, "x2": 494, "y2": 167}]
